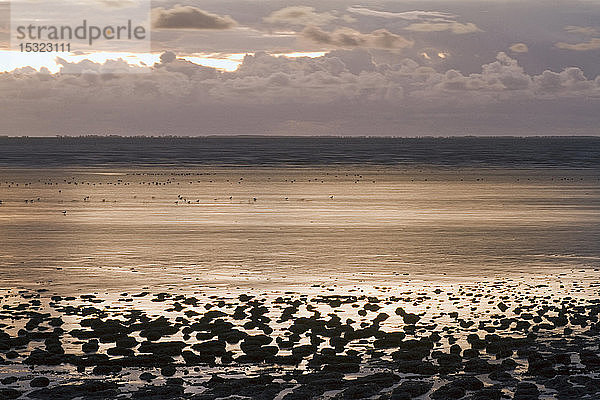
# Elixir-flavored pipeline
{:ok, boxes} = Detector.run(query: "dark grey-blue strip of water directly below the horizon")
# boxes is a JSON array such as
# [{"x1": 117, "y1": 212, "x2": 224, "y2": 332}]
[{"x1": 0, "y1": 136, "x2": 600, "y2": 169}]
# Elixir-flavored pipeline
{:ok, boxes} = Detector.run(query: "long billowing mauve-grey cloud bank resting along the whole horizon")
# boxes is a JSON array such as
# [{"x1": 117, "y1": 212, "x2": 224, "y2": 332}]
[{"x1": 0, "y1": 48, "x2": 600, "y2": 135}]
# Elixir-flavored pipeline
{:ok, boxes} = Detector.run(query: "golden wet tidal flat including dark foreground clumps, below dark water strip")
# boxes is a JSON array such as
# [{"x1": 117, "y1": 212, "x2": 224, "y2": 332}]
[{"x1": 0, "y1": 166, "x2": 600, "y2": 400}]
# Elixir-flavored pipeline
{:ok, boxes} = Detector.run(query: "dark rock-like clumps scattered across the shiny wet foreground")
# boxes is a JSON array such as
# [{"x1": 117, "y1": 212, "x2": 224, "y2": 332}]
[{"x1": 0, "y1": 280, "x2": 600, "y2": 400}]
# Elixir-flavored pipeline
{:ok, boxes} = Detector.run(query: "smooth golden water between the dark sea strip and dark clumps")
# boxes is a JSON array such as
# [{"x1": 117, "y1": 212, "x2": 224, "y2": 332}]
[{"x1": 0, "y1": 166, "x2": 600, "y2": 288}]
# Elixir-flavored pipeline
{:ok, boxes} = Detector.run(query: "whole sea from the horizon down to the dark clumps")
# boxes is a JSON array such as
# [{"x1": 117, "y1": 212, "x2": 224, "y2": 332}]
[{"x1": 0, "y1": 136, "x2": 600, "y2": 293}]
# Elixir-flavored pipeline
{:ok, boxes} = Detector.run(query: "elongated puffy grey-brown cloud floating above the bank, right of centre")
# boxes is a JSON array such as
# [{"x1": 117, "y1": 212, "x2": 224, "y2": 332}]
[{"x1": 302, "y1": 26, "x2": 414, "y2": 49}]
